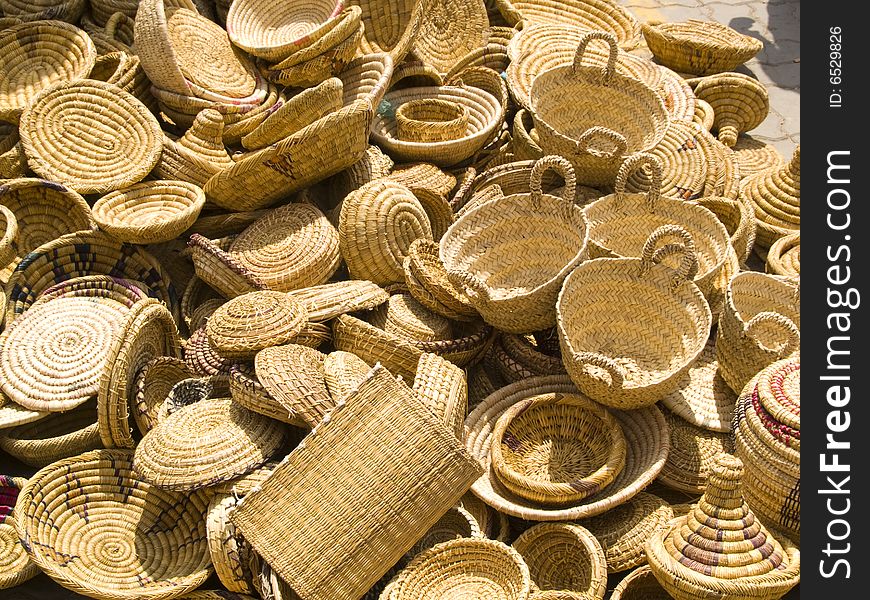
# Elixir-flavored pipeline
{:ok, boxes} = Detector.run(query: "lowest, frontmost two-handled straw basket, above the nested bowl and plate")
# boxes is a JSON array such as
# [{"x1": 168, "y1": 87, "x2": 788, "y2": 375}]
[{"x1": 556, "y1": 225, "x2": 712, "y2": 409}]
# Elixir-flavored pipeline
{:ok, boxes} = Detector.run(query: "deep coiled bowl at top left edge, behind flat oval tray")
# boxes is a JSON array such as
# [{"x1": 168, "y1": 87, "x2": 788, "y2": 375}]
[{"x1": 0, "y1": 21, "x2": 97, "y2": 123}]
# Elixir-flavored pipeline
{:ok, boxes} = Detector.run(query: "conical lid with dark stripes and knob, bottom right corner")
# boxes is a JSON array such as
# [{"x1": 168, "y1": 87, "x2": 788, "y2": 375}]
[{"x1": 663, "y1": 454, "x2": 787, "y2": 579}]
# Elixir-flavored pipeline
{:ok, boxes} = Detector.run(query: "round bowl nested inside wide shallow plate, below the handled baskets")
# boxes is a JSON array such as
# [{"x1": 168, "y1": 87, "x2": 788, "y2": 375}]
[{"x1": 491, "y1": 394, "x2": 625, "y2": 504}]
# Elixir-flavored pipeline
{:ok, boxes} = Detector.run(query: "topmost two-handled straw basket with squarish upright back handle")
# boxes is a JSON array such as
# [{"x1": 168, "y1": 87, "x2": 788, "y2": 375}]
[{"x1": 529, "y1": 32, "x2": 669, "y2": 185}]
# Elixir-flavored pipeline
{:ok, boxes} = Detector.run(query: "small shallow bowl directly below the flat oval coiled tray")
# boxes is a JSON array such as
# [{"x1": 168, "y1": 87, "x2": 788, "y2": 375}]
[{"x1": 93, "y1": 179, "x2": 205, "y2": 244}]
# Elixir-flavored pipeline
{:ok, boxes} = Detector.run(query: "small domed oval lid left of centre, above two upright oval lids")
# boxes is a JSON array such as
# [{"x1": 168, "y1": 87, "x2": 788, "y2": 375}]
[{"x1": 205, "y1": 291, "x2": 308, "y2": 358}]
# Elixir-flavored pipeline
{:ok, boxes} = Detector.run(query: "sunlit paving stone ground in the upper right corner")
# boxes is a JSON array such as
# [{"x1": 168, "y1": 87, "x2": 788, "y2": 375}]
[{"x1": 619, "y1": 0, "x2": 801, "y2": 158}]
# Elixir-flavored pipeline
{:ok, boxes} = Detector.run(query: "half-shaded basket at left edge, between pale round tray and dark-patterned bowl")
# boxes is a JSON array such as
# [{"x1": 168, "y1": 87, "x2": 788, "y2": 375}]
[{"x1": 0, "y1": 401, "x2": 102, "y2": 467}]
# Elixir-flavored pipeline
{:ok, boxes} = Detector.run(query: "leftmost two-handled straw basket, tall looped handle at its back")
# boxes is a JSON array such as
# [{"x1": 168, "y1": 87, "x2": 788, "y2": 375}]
[{"x1": 440, "y1": 157, "x2": 589, "y2": 333}]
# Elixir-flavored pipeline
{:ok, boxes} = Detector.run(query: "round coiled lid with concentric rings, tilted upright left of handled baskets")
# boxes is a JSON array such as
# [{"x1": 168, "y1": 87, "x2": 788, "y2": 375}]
[{"x1": 338, "y1": 180, "x2": 432, "y2": 285}]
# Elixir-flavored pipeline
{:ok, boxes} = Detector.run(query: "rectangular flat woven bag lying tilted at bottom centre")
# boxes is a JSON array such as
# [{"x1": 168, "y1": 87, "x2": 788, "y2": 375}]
[{"x1": 231, "y1": 365, "x2": 482, "y2": 600}]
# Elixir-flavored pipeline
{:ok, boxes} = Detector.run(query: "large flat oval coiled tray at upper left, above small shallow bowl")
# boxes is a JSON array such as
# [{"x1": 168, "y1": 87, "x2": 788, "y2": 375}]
[{"x1": 20, "y1": 79, "x2": 162, "y2": 194}]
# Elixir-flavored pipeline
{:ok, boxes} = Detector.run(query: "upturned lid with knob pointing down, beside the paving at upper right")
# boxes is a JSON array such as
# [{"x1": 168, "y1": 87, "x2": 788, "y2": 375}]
[{"x1": 695, "y1": 73, "x2": 770, "y2": 147}]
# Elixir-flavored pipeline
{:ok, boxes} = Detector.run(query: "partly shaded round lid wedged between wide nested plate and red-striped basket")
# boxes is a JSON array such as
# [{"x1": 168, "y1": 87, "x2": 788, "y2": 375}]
[{"x1": 658, "y1": 411, "x2": 734, "y2": 494}]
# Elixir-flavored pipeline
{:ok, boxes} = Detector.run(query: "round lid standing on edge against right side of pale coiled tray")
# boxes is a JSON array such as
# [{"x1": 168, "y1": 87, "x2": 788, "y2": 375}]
[{"x1": 97, "y1": 298, "x2": 181, "y2": 448}]
